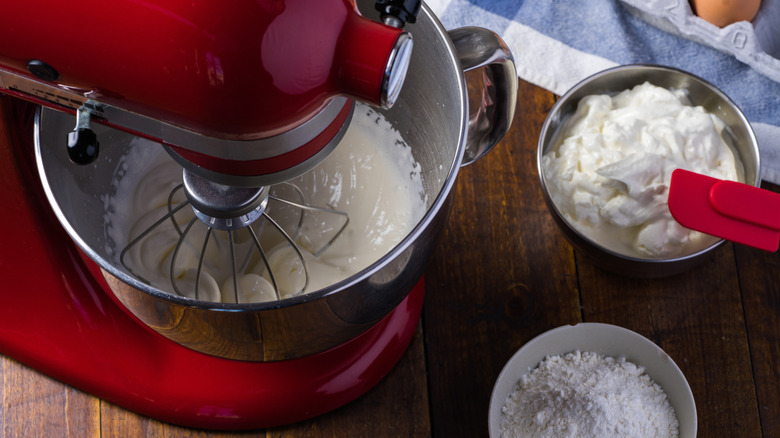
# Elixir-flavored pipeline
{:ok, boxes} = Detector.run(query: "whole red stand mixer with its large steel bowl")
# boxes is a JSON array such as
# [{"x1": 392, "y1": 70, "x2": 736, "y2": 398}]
[{"x1": 0, "y1": 0, "x2": 517, "y2": 429}]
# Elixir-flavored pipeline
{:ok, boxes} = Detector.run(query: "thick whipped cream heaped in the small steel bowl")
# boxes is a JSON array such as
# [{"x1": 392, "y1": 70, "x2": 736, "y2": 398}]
[{"x1": 542, "y1": 83, "x2": 742, "y2": 258}]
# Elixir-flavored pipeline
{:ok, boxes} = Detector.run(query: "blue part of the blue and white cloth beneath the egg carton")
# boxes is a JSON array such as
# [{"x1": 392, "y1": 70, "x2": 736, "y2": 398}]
[{"x1": 431, "y1": 0, "x2": 780, "y2": 182}]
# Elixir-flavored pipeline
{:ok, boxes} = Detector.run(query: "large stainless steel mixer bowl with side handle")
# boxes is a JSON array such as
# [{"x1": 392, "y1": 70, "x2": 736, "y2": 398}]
[{"x1": 36, "y1": 1, "x2": 517, "y2": 361}]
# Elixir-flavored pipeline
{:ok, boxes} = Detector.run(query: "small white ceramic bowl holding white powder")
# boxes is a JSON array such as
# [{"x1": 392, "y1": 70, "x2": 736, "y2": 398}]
[{"x1": 488, "y1": 323, "x2": 697, "y2": 438}]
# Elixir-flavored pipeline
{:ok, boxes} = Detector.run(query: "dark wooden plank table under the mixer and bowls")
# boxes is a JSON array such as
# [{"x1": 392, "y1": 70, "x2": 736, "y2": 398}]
[{"x1": 0, "y1": 81, "x2": 780, "y2": 437}]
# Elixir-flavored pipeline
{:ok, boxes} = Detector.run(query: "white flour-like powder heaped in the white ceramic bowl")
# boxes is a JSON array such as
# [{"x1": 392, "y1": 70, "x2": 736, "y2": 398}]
[{"x1": 501, "y1": 351, "x2": 679, "y2": 438}]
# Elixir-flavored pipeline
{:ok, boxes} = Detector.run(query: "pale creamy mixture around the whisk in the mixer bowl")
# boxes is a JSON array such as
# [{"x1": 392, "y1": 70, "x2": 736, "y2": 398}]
[{"x1": 106, "y1": 105, "x2": 427, "y2": 303}]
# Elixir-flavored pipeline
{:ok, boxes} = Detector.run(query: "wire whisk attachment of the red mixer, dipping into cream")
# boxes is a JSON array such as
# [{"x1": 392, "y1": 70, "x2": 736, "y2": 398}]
[{"x1": 119, "y1": 170, "x2": 349, "y2": 303}]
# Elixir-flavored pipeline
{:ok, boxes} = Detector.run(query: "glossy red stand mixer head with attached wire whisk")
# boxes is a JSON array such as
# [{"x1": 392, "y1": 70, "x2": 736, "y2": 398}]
[{"x1": 0, "y1": 0, "x2": 420, "y2": 302}]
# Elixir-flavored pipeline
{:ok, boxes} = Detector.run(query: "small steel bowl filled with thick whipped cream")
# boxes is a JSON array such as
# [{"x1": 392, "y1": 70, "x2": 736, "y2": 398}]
[{"x1": 537, "y1": 65, "x2": 761, "y2": 277}]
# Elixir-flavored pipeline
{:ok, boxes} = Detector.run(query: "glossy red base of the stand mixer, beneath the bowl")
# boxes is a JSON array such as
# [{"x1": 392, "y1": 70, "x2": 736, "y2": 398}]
[{"x1": 0, "y1": 97, "x2": 424, "y2": 429}]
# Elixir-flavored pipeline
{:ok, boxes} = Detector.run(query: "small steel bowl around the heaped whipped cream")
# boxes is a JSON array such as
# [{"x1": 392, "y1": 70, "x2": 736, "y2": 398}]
[{"x1": 537, "y1": 64, "x2": 761, "y2": 278}]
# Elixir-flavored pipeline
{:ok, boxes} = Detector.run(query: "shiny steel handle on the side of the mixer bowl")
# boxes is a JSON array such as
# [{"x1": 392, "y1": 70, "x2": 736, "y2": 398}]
[{"x1": 448, "y1": 27, "x2": 517, "y2": 166}]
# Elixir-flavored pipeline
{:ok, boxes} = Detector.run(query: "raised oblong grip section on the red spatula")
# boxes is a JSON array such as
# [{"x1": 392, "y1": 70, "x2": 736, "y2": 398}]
[{"x1": 710, "y1": 180, "x2": 780, "y2": 230}]
